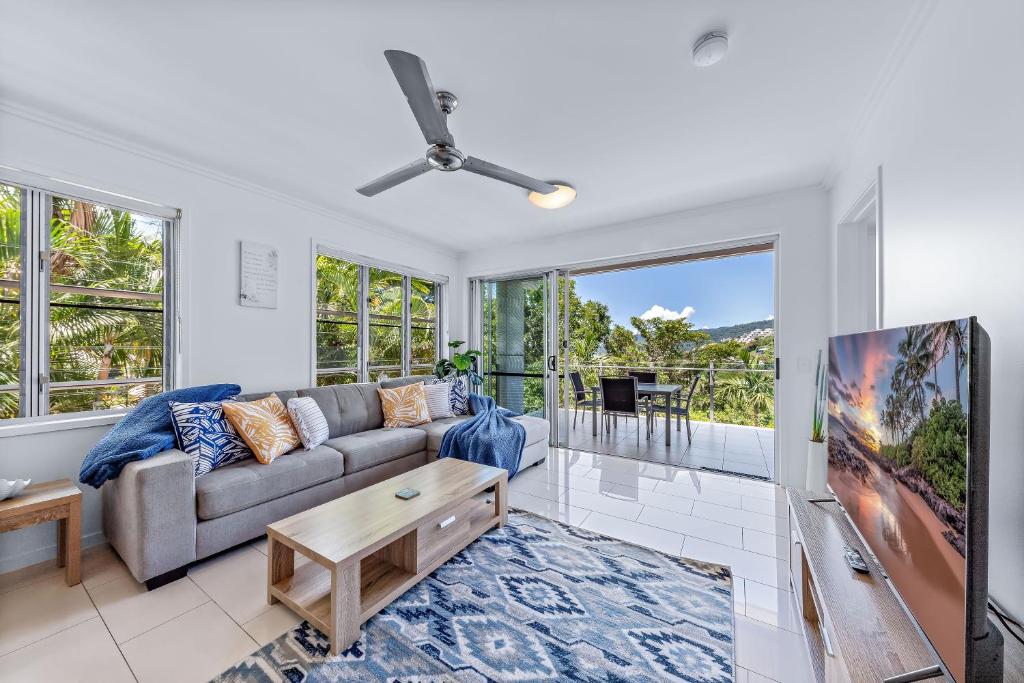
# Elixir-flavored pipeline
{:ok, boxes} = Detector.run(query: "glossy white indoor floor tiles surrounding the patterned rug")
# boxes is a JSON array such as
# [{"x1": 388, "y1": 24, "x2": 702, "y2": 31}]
[{"x1": 0, "y1": 450, "x2": 811, "y2": 683}]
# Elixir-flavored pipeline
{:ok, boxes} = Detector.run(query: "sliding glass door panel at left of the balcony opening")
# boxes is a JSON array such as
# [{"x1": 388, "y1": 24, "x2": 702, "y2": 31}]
[{"x1": 474, "y1": 270, "x2": 566, "y2": 444}]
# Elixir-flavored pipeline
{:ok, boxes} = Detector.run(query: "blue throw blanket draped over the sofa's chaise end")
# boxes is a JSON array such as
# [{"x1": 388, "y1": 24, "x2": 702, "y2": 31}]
[{"x1": 437, "y1": 393, "x2": 526, "y2": 477}]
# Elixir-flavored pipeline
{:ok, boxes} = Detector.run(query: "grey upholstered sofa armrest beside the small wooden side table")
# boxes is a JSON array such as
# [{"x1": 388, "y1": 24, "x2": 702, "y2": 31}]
[{"x1": 102, "y1": 450, "x2": 196, "y2": 582}]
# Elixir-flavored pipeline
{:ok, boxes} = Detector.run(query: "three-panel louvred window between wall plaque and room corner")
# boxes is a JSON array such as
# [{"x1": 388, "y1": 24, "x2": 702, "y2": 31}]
[{"x1": 314, "y1": 248, "x2": 443, "y2": 386}]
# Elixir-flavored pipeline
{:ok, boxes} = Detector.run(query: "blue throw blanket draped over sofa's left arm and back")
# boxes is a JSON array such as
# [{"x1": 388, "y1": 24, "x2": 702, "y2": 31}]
[{"x1": 78, "y1": 384, "x2": 242, "y2": 488}]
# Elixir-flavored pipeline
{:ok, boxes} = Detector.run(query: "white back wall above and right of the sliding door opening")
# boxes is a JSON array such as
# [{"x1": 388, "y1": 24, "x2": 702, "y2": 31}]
[{"x1": 460, "y1": 188, "x2": 829, "y2": 485}]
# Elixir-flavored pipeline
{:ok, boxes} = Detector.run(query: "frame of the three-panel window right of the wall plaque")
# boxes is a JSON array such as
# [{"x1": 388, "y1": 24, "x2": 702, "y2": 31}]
[{"x1": 309, "y1": 240, "x2": 449, "y2": 386}]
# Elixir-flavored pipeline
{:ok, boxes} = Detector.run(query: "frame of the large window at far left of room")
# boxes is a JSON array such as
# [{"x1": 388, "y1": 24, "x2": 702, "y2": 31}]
[{"x1": 0, "y1": 171, "x2": 181, "y2": 428}]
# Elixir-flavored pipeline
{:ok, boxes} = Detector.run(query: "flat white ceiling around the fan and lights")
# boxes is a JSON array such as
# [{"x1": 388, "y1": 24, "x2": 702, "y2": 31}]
[{"x1": 0, "y1": 0, "x2": 915, "y2": 250}]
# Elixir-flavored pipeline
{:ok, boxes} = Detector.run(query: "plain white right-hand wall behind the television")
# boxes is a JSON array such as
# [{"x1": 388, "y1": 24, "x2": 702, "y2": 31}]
[{"x1": 831, "y1": 0, "x2": 1024, "y2": 617}]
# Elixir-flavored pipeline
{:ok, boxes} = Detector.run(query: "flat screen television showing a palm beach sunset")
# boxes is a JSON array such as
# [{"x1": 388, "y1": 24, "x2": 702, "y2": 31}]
[{"x1": 828, "y1": 317, "x2": 1002, "y2": 683}]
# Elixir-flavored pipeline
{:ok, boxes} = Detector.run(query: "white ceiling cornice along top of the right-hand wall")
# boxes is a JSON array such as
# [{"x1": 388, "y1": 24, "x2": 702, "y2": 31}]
[{"x1": 821, "y1": 0, "x2": 938, "y2": 189}]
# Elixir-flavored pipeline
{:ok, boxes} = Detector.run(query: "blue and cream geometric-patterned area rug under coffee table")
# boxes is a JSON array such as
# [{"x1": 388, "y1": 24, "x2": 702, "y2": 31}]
[{"x1": 215, "y1": 510, "x2": 735, "y2": 683}]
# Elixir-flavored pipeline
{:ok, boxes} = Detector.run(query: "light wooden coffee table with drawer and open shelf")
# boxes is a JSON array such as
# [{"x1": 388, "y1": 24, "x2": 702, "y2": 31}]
[{"x1": 266, "y1": 458, "x2": 508, "y2": 654}]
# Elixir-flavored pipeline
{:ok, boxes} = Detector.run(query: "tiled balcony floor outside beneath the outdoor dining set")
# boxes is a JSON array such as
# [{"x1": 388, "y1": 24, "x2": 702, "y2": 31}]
[{"x1": 562, "y1": 410, "x2": 775, "y2": 480}]
